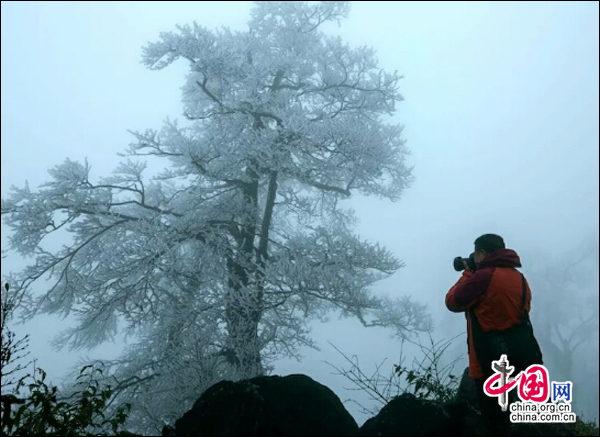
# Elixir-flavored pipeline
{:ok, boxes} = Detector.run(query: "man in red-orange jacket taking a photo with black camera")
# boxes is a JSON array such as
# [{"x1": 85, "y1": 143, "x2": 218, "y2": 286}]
[{"x1": 446, "y1": 234, "x2": 542, "y2": 435}]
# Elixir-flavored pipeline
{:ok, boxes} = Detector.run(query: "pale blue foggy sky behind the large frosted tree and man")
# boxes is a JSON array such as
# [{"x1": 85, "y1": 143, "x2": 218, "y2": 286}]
[{"x1": 1, "y1": 2, "x2": 599, "y2": 424}]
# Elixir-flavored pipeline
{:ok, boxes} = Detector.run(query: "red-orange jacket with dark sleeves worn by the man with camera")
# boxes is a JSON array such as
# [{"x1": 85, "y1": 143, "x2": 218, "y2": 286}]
[{"x1": 446, "y1": 249, "x2": 531, "y2": 379}]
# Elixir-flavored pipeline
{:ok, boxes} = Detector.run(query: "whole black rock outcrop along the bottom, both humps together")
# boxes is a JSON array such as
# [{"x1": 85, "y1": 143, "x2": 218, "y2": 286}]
[{"x1": 170, "y1": 370, "x2": 592, "y2": 436}]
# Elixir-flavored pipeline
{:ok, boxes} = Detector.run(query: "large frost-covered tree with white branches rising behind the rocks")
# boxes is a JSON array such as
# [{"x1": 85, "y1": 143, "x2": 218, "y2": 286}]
[{"x1": 2, "y1": 2, "x2": 430, "y2": 432}]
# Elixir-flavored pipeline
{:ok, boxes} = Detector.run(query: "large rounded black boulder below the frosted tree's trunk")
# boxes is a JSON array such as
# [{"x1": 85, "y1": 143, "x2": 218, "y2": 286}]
[{"x1": 175, "y1": 375, "x2": 358, "y2": 436}]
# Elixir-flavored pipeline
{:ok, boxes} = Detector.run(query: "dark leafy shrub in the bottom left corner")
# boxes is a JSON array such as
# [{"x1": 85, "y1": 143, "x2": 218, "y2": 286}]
[{"x1": 0, "y1": 284, "x2": 131, "y2": 436}]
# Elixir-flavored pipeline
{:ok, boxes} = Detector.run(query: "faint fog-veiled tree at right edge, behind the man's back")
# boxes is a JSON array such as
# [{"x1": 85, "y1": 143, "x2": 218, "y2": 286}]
[{"x1": 528, "y1": 232, "x2": 600, "y2": 418}]
